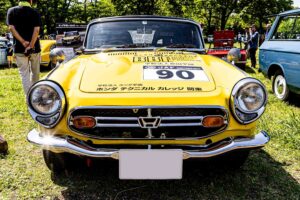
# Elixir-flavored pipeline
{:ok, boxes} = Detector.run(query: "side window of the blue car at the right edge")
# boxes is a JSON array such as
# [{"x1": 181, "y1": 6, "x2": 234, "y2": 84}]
[{"x1": 271, "y1": 15, "x2": 300, "y2": 40}]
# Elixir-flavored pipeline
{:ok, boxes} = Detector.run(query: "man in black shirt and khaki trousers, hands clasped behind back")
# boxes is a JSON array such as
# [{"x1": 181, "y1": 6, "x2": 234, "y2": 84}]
[{"x1": 6, "y1": 0, "x2": 41, "y2": 95}]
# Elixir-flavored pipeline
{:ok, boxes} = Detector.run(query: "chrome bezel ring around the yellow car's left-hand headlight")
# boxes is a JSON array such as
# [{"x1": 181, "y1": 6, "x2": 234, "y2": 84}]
[{"x1": 27, "y1": 80, "x2": 66, "y2": 128}]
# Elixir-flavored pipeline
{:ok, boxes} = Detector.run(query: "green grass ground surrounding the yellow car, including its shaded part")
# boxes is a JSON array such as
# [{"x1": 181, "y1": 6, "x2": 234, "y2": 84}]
[{"x1": 0, "y1": 65, "x2": 300, "y2": 200}]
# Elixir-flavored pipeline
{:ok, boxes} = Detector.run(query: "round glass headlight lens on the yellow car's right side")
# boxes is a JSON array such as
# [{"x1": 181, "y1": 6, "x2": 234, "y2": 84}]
[{"x1": 236, "y1": 83, "x2": 266, "y2": 112}]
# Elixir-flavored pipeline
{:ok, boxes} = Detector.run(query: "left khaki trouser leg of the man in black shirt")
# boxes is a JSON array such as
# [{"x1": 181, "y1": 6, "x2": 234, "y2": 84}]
[{"x1": 16, "y1": 54, "x2": 31, "y2": 95}]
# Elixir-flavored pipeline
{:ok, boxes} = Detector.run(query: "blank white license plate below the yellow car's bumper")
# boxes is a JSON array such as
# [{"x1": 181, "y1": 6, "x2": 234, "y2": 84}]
[{"x1": 119, "y1": 149, "x2": 183, "y2": 179}]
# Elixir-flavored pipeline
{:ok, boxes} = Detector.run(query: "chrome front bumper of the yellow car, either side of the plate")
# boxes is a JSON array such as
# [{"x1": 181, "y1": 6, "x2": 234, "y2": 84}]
[{"x1": 27, "y1": 129, "x2": 270, "y2": 159}]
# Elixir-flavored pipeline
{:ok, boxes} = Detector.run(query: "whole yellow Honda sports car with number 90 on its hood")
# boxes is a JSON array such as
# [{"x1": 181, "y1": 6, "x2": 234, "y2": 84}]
[{"x1": 27, "y1": 16, "x2": 269, "y2": 179}]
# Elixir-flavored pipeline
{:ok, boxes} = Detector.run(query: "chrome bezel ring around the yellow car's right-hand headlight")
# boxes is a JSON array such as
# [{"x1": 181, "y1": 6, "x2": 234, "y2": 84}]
[{"x1": 230, "y1": 77, "x2": 268, "y2": 124}]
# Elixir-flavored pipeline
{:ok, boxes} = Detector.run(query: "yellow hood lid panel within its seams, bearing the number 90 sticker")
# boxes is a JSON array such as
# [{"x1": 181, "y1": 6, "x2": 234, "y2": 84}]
[{"x1": 80, "y1": 51, "x2": 215, "y2": 93}]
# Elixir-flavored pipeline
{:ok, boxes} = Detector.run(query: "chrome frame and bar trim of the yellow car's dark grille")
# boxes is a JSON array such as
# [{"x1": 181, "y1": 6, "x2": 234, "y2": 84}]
[{"x1": 67, "y1": 105, "x2": 229, "y2": 140}]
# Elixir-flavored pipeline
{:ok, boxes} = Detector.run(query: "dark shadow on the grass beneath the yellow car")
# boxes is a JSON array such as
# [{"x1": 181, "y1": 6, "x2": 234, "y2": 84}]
[{"x1": 52, "y1": 150, "x2": 300, "y2": 200}]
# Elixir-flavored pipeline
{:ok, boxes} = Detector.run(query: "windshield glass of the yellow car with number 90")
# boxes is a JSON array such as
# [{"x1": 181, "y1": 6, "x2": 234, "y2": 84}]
[{"x1": 85, "y1": 20, "x2": 201, "y2": 49}]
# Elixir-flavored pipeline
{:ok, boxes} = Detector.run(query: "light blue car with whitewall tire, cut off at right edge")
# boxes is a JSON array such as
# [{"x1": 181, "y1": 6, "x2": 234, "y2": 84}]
[{"x1": 259, "y1": 9, "x2": 300, "y2": 101}]
